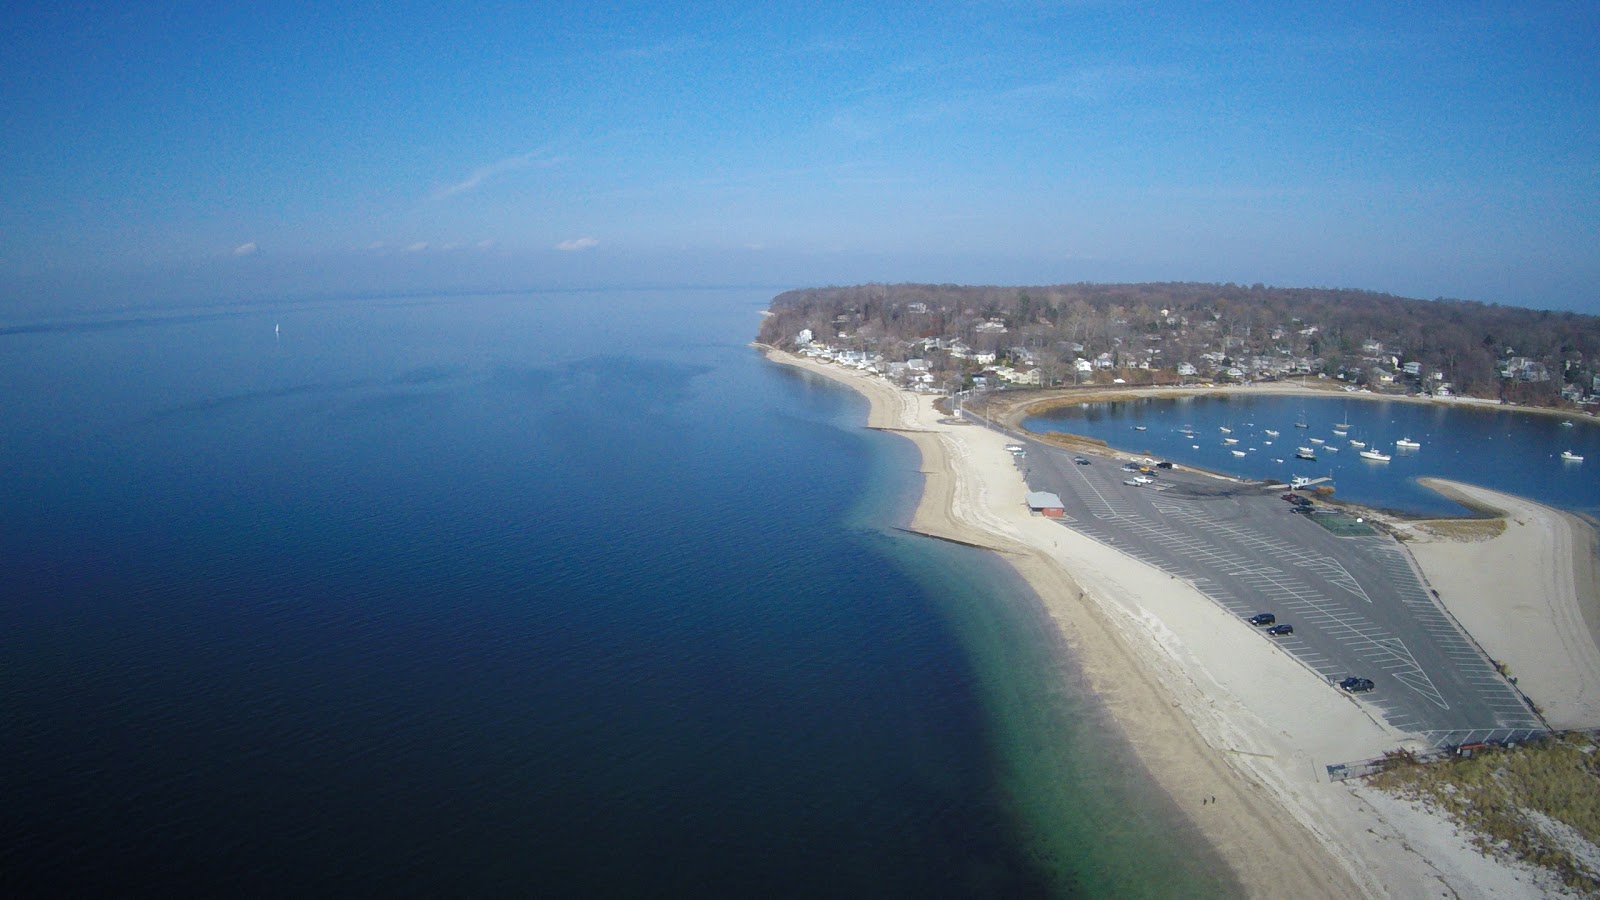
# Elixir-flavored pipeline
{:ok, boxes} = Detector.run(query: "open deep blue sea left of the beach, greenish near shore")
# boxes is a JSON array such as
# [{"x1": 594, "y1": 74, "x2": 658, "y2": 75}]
[{"x1": 0, "y1": 291, "x2": 1235, "y2": 895}]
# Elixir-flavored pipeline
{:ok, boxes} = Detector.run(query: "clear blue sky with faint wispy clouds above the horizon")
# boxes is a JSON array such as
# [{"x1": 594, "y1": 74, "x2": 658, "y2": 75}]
[{"x1": 0, "y1": 2, "x2": 1600, "y2": 312}]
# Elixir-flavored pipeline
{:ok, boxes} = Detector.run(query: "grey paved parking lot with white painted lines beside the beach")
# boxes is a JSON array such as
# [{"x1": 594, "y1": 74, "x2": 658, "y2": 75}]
[{"x1": 1018, "y1": 439, "x2": 1542, "y2": 746}]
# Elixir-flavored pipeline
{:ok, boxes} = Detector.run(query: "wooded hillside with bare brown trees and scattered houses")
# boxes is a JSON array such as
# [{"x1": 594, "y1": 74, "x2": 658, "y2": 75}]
[{"x1": 762, "y1": 282, "x2": 1600, "y2": 402}]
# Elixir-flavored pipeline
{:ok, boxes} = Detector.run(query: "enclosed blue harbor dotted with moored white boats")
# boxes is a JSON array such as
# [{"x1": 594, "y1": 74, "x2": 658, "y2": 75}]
[{"x1": 1024, "y1": 394, "x2": 1600, "y2": 516}]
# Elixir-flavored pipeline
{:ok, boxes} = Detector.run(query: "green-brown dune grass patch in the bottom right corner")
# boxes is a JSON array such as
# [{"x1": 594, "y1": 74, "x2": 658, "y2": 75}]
[{"x1": 1370, "y1": 735, "x2": 1600, "y2": 897}]
